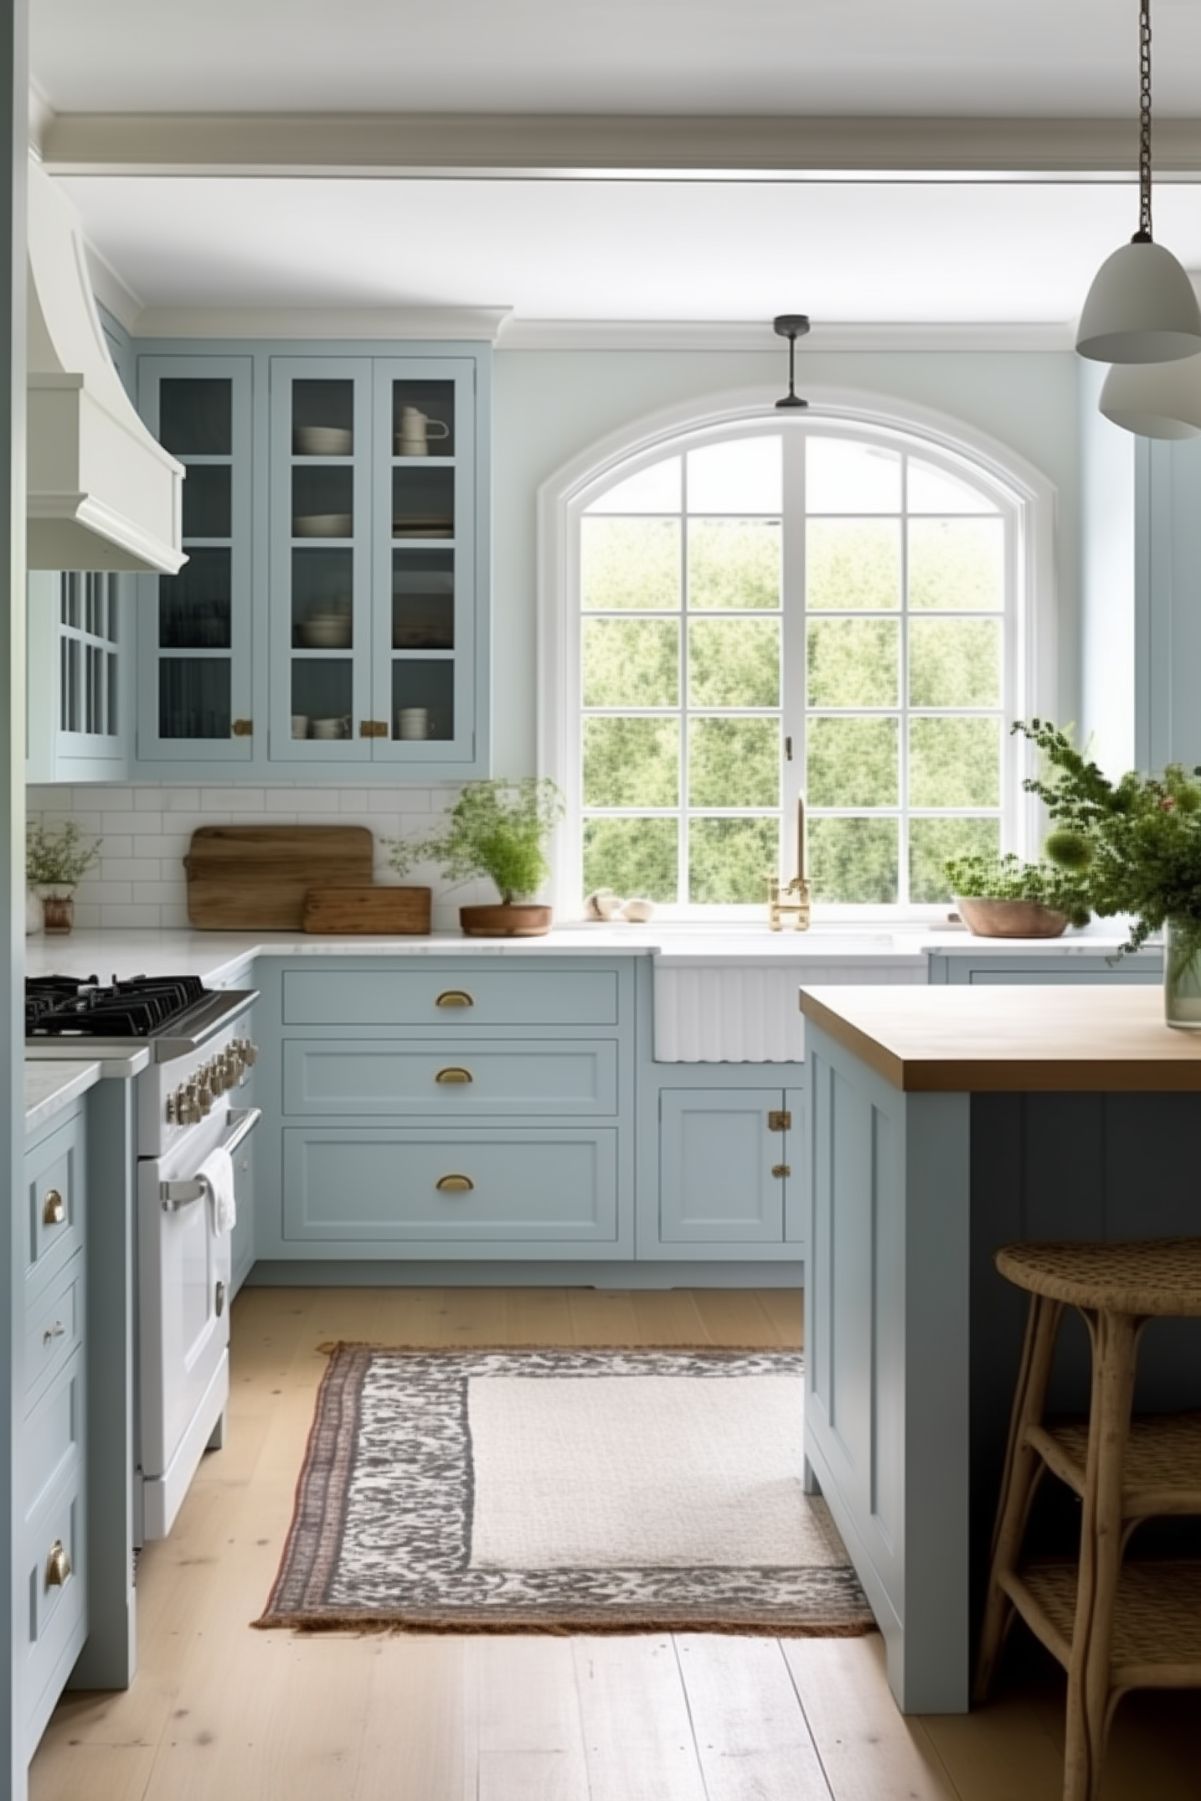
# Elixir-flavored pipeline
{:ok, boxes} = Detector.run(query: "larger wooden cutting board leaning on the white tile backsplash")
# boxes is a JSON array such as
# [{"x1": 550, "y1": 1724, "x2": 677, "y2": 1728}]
[{"x1": 184, "y1": 825, "x2": 373, "y2": 931}]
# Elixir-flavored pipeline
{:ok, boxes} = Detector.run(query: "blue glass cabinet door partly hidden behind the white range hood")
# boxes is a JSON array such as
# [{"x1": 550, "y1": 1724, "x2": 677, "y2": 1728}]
[{"x1": 137, "y1": 357, "x2": 254, "y2": 762}]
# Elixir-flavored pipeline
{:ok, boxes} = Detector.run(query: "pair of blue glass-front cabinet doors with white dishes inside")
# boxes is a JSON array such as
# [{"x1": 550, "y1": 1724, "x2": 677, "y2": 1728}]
[{"x1": 270, "y1": 357, "x2": 477, "y2": 765}]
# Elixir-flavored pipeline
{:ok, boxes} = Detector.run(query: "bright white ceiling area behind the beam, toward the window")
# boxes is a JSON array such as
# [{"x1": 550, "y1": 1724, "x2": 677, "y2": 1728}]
[{"x1": 65, "y1": 176, "x2": 1201, "y2": 324}]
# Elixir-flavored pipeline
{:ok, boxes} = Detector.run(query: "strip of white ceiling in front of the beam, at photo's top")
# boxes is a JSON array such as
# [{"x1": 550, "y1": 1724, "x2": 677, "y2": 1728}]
[{"x1": 32, "y1": 0, "x2": 1201, "y2": 117}]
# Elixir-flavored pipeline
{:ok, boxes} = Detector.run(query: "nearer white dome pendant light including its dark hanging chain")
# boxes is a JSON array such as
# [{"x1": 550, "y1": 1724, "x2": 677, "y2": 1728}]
[{"x1": 1077, "y1": 0, "x2": 1201, "y2": 364}]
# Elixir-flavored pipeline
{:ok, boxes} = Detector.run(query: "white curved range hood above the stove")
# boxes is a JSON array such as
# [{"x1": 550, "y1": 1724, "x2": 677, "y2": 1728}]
[{"x1": 27, "y1": 164, "x2": 187, "y2": 575}]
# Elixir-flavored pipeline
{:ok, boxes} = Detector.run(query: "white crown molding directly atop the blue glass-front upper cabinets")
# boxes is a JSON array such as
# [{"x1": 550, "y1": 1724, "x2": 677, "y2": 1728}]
[{"x1": 127, "y1": 295, "x2": 510, "y2": 344}]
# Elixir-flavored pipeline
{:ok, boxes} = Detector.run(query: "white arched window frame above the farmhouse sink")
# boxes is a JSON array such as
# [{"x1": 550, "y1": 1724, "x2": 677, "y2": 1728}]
[{"x1": 537, "y1": 384, "x2": 1057, "y2": 920}]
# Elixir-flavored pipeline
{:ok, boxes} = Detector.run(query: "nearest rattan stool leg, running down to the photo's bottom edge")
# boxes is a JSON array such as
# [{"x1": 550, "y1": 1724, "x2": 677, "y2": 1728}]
[{"x1": 1064, "y1": 1313, "x2": 1142, "y2": 1801}]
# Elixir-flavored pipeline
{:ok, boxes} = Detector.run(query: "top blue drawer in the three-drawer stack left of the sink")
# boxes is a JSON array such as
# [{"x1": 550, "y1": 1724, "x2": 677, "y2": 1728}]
[{"x1": 283, "y1": 958, "x2": 618, "y2": 1032}]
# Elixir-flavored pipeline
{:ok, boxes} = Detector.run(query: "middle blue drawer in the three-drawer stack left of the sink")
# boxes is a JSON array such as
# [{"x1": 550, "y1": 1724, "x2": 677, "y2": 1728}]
[{"x1": 283, "y1": 1039, "x2": 618, "y2": 1120}]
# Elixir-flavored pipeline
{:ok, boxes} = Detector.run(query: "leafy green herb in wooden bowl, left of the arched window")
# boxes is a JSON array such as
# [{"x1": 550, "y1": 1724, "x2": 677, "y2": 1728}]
[{"x1": 389, "y1": 776, "x2": 564, "y2": 938}]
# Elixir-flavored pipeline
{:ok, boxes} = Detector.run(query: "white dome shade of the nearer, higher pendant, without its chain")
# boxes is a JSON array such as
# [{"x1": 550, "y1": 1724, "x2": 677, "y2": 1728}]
[{"x1": 1077, "y1": 240, "x2": 1201, "y2": 364}]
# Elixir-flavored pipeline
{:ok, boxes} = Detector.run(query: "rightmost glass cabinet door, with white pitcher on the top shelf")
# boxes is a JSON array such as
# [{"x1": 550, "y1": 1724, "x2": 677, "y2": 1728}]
[{"x1": 373, "y1": 357, "x2": 477, "y2": 764}]
